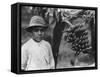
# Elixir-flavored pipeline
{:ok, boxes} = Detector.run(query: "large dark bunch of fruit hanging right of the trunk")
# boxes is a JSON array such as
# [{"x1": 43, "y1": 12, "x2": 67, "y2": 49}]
[{"x1": 65, "y1": 25, "x2": 92, "y2": 56}]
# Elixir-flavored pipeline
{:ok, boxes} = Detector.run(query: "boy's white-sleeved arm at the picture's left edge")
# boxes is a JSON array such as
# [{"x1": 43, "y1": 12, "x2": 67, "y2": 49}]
[{"x1": 21, "y1": 46, "x2": 28, "y2": 70}]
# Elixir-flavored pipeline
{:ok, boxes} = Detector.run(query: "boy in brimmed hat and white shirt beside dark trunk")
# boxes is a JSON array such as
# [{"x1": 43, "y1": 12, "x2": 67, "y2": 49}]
[{"x1": 21, "y1": 16, "x2": 55, "y2": 71}]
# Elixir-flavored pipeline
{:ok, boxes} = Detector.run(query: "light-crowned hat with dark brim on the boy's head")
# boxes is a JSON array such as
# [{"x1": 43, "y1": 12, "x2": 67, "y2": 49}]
[{"x1": 25, "y1": 16, "x2": 48, "y2": 32}]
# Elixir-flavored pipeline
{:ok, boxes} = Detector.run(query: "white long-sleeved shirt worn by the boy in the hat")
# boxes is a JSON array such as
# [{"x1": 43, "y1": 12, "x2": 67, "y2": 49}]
[{"x1": 21, "y1": 39, "x2": 55, "y2": 70}]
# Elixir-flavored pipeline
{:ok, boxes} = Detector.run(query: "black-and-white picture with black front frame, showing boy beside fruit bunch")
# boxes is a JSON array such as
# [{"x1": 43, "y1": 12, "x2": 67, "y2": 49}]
[{"x1": 11, "y1": 4, "x2": 97, "y2": 72}]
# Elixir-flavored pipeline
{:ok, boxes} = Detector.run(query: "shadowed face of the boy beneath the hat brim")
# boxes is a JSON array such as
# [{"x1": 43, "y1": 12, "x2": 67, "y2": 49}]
[{"x1": 32, "y1": 27, "x2": 45, "y2": 42}]
